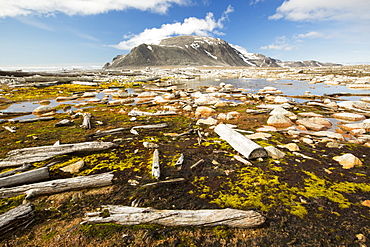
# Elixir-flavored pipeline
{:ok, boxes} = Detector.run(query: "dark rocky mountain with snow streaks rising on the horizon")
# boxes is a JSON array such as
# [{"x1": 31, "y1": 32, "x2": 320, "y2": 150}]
[{"x1": 103, "y1": 35, "x2": 340, "y2": 69}]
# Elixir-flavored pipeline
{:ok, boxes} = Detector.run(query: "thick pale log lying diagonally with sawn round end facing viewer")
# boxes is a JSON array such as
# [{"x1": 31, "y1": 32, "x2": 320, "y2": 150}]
[{"x1": 215, "y1": 124, "x2": 268, "y2": 159}]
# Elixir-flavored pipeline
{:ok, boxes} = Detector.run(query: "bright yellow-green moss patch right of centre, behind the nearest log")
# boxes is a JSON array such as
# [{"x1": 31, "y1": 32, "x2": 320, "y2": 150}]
[{"x1": 192, "y1": 164, "x2": 370, "y2": 217}]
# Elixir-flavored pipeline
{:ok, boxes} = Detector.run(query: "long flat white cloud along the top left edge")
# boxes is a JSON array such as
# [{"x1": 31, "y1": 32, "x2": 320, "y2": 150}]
[{"x1": 0, "y1": 0, "x2": 191, "y2": 17}]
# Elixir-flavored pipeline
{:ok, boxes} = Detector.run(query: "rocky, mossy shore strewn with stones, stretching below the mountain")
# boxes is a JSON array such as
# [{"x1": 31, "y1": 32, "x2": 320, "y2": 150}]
[{"x1": 0, "y1": 65, "x2": 370, "y2": 246}]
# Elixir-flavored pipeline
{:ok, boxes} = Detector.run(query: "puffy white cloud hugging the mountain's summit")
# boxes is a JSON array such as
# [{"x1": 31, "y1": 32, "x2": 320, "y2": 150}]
[{"x1": 110, "y1": 6, "x2": 234, "y2": 50}]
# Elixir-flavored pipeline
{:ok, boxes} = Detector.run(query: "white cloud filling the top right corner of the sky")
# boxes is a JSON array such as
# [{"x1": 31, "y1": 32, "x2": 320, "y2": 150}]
[{"x1": 269, "y1": 0, "x2": 370, "y2": 21}]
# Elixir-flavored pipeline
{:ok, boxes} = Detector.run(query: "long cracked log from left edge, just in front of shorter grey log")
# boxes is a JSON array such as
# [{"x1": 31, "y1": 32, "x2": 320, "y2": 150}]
[{"x1": 0, "y1": 172, "x2": 113, "y2": 199}]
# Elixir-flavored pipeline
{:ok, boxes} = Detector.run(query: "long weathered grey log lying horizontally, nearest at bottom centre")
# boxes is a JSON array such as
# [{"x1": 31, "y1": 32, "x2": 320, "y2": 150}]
[{"x1": 83, "y1": 205, "x2": 265, "y2": 228}]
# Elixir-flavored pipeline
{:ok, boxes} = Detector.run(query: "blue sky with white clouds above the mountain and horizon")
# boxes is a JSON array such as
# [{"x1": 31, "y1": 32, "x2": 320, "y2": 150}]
[{"x1": 0, "y1": 0, "x2": 370, "y2": 69}]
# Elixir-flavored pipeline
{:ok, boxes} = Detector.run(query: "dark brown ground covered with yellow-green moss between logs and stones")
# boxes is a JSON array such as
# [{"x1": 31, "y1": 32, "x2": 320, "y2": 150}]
[{"x1": 0, "y1": 79, "x2": 370, "y2": 246}]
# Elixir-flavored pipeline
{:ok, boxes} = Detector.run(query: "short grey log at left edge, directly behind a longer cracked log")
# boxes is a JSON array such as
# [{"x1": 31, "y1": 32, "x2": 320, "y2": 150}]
[{"x1": 0, "y1": 167, "x2": 50, "y2": 188}]
